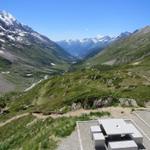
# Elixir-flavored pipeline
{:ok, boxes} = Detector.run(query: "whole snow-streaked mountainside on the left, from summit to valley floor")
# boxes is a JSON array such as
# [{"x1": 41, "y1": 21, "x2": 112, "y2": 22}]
[{"x1": 0, "y1": 11, "x2": 72, "y2": 92}]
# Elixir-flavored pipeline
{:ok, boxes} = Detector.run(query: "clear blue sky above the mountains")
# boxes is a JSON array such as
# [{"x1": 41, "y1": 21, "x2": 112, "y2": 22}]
[{"x1": 0, "y1": 0, "x2": 150, "y2": 40}]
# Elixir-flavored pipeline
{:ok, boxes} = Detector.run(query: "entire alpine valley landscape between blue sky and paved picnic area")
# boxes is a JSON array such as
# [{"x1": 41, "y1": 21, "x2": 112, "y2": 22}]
[{"x1": 0, "y1": 11, "x2": 150, "y2": 150}]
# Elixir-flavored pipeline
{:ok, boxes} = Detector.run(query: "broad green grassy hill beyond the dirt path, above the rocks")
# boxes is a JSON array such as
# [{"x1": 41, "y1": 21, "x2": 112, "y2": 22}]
[{"x1": 0, "y1": 57, "x2": 150, "y2": 117}]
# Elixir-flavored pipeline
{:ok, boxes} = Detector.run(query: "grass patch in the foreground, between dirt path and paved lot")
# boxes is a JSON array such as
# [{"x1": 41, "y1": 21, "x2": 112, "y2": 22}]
[{"x1": 0, "y1": 112, "x2": 109, "y2": 150}]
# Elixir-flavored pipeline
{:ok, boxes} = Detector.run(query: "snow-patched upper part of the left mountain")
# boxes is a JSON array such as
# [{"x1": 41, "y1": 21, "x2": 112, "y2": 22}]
[{"x1": 0, "y1": 11, "x2": 49, "y2": 45}]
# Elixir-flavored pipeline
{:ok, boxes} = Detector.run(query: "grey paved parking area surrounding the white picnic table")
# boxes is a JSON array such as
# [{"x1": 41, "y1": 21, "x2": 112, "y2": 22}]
[{"x1": 58, "y1": 110, "x2": 150, "y2": 150}]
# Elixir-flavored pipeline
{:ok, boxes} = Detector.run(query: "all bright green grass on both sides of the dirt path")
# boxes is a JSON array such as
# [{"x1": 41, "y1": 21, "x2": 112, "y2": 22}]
[{"x1": 0, "y1": 57, "x2": 150, "y2": 150}]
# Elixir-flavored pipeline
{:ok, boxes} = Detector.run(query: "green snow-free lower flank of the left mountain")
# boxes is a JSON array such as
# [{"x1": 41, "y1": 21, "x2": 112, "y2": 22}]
[{"x1": 0, "y1": 43, "x2": 71, "y2": 92}]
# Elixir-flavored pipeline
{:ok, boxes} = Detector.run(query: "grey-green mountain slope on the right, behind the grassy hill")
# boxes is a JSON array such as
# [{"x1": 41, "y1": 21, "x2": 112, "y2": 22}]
[{"x1": 84, "y1": 26, "x2": 150, "y2": 65}]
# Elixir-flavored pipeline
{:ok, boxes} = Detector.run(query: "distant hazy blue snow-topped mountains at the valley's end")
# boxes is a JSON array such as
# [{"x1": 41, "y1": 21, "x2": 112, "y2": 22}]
[{"x1": 57, "y1": 36, "x2": 115, "y2": 58}]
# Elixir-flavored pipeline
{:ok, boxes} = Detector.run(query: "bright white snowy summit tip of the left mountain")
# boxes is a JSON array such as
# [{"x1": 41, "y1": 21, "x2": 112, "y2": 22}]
[{"x1": 0, "y1": 11, "x2": 16, "y2": 25}]
